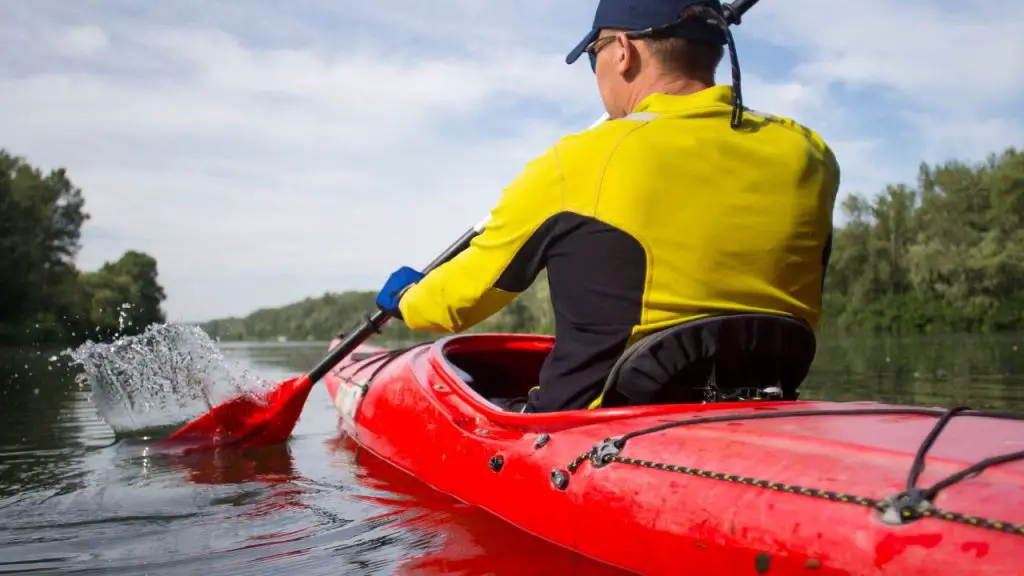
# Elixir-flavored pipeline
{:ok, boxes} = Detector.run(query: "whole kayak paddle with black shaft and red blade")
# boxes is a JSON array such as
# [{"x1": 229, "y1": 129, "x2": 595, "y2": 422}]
[{"x1": 161, "y1": 0, "x2": 758, "y2": 451}]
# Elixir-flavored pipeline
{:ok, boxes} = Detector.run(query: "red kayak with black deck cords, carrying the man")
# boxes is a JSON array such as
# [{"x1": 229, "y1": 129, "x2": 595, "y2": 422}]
[{"x1": 325, "y1": 334, "x2": 1024, "y2": 575}]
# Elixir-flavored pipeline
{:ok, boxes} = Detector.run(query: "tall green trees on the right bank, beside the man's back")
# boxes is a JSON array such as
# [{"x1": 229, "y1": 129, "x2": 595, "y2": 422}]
[{"x1": 823, "y1": 149, "x2": 1024, "y2": 333}]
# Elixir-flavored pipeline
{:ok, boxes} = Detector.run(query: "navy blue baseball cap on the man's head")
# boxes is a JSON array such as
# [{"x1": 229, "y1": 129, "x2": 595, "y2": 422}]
[{"x1": 565, "y1": 0, "x2": 725, "y2": 64}]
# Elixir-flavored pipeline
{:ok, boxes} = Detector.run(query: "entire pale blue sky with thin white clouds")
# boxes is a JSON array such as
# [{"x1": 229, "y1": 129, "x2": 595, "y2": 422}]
[{"x1": 0, "y1": 0, "x2": 1024, "y2": 321}]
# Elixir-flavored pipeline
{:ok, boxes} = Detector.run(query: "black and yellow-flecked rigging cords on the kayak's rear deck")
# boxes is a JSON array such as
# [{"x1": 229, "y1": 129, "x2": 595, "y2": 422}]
[{"x1": 551, "y1": 406, "x2": 1024, "y2": 536}]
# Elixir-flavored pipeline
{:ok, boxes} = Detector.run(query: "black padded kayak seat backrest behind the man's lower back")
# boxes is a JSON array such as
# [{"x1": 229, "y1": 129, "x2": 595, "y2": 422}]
[{"x1": 600, "y1": 314, "x2": 817, "y2": 408}]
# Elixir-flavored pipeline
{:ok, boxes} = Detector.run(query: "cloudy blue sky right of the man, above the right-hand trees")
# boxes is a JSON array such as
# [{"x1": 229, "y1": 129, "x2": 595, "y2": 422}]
[{"x1": 745, "y1": 0, "x2": 1024, "y2": 183}]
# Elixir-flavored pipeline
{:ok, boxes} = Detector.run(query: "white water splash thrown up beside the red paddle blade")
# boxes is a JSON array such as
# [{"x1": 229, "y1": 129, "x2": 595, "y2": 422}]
[{"x1": 63, "y1": 324, "x2": 270, "y2": 435}]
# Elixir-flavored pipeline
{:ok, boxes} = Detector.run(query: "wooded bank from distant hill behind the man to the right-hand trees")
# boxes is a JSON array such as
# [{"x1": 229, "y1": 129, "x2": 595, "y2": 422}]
[{"x1": 203, "y1": 148, "x2": 1024, "y2": 340}]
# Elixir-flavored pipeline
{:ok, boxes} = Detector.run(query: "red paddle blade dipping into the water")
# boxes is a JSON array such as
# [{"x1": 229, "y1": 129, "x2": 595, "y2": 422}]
[{"x1": 161, "y1": 374, "x2": 313, "y2": 452}]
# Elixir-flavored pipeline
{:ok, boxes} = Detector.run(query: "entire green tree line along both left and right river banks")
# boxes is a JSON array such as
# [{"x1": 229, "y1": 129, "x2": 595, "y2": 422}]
[{"x1": 9, "y1": 143, "x2": 1024, "y2": 343}]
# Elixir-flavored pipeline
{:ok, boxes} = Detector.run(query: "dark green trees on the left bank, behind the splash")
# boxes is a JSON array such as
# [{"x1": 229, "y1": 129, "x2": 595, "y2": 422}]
[{"x1": 0, "y1": 149, "x2": 166, "y2": 344}]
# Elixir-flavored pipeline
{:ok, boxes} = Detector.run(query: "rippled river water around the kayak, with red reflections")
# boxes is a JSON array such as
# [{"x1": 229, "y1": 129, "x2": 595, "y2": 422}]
[{"x1": 0, "y1": 325, "x2": 1024, "y2": 576}]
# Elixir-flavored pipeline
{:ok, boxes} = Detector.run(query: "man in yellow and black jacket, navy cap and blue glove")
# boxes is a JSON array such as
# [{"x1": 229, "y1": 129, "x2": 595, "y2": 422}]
[{"x1": 378, "y1": 0, "x2": 839, "y2": 413}]
